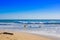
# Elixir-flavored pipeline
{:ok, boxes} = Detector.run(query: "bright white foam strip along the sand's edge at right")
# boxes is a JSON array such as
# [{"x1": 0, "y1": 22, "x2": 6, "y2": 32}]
[{"x1": 24, "y1": 31, "x2": 60, "y2": 38}]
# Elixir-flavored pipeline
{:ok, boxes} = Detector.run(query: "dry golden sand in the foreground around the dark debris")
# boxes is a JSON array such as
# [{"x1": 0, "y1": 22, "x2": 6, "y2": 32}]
[{"x1": 0, "y1": 32, "x2": 52, "y2": 40}]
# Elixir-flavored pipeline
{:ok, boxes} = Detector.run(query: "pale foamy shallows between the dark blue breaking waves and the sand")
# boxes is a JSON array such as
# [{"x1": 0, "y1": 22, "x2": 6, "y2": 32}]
[{"x1": 0, "y1": 23, "x2": 60, "y2": 37}]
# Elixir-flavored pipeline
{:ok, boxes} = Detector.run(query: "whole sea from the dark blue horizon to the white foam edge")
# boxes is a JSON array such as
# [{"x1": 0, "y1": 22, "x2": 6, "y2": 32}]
[{"x1": 0, "y1": 19, "x2": 60, "y2": 37}]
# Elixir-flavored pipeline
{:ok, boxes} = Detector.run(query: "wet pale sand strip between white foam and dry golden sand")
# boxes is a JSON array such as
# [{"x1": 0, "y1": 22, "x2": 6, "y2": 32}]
[{"x1": 0, "y1": 30, "x2": 60, "y2": 40}]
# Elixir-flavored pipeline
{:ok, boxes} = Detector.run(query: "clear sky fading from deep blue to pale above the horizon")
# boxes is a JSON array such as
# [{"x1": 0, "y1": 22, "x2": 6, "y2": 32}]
[{"x1": 0, "y1": 0, "x2": 60, "y2": 19}]
